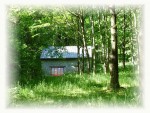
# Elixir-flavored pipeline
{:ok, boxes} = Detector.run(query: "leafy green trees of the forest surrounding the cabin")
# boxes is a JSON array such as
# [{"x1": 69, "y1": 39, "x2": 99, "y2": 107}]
[{"x1": 8, "y1": 6, "x2": 141, "y2": 87}]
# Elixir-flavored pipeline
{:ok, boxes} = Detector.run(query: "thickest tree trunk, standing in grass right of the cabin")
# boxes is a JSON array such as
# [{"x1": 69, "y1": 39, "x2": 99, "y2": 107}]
[{"x1": 109, "y1": 7, "x2": 120, "y2": 90}]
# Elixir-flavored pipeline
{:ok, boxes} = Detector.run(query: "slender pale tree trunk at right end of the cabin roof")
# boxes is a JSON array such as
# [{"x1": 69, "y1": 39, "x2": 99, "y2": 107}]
[{"x1": 91, "y1": 15, "x2": 96, "y2": 75}]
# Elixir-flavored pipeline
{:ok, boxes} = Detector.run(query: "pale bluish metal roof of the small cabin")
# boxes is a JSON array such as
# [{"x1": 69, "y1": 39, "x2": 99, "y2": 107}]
[{"x1": 40, "y1": 46, "x2": 92, "y2": 59}]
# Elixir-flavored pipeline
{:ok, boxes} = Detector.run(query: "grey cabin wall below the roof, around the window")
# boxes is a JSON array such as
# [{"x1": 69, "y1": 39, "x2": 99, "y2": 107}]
[{"x1": 42, "y1": 59, "x2": 78, "y2": 76}]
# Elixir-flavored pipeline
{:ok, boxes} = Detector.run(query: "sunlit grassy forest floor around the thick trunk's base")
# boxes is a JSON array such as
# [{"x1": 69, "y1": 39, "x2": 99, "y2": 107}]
[{"x1": 9, "y1": 66, "x2": 142, "y2": 107}]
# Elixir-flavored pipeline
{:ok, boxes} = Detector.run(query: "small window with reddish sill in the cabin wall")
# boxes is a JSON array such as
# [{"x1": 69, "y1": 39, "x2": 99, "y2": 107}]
[{"x1": 51, "y1": 67, "x2": 64, "y2": 76}]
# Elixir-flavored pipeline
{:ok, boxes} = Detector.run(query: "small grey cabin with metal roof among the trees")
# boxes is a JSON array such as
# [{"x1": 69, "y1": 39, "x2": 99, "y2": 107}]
[{"x1": 40, "y1": 46, "x2": 92, "y2": 76}]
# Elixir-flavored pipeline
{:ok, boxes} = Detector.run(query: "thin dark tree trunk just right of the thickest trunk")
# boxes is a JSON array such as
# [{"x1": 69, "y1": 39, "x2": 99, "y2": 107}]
[{"x1": 122, "y1": 9, "x2": 126, "y2": 68}]
